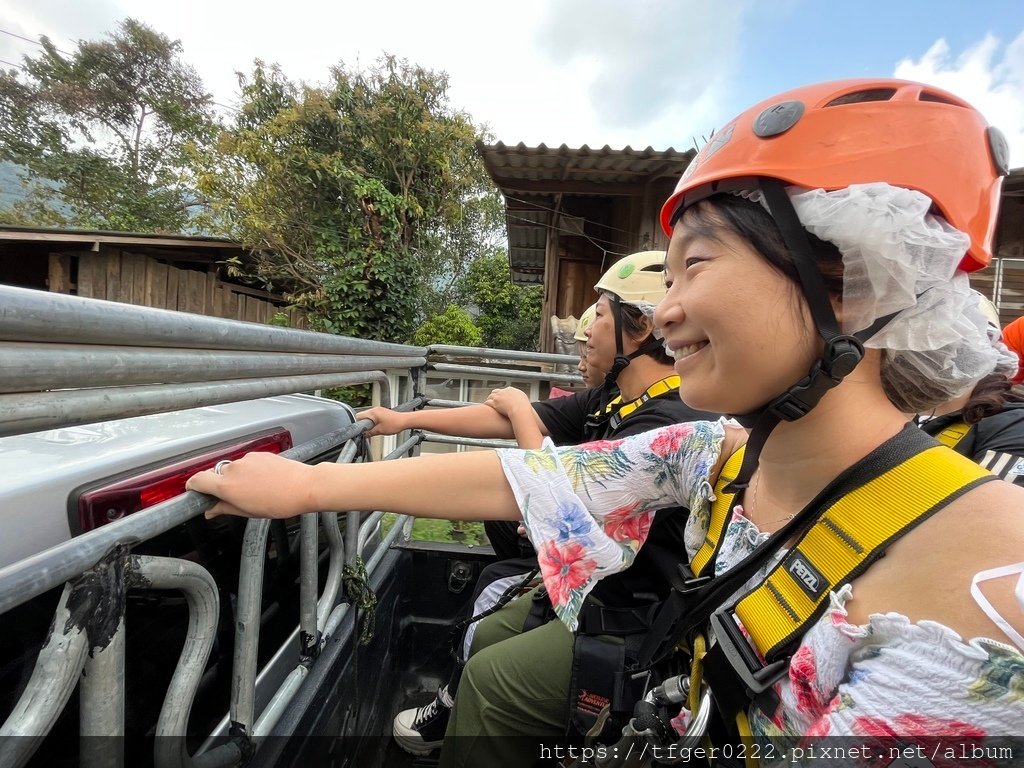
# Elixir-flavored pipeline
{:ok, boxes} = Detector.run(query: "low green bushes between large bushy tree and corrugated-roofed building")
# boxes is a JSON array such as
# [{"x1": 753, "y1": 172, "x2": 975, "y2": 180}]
[{"x1": 461, "y1": 250, "x2": 544, "y2": 351}]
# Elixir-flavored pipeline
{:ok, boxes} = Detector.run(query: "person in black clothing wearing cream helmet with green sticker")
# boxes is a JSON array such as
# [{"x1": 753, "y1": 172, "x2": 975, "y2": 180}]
[{"x1": 372, "y1": 251, "x2": 718, "y2": 754}]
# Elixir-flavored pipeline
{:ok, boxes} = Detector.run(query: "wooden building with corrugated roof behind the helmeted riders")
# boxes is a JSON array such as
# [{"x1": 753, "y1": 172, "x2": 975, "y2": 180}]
[{"x1": 478, "y1": 142, "x2": 1024, "y2": 352}]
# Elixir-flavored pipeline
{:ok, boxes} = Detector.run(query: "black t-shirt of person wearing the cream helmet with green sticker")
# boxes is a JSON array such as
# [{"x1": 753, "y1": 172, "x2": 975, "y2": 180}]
[{"x1": 534, "y1": 388, "x2": 719, "y2": 607}]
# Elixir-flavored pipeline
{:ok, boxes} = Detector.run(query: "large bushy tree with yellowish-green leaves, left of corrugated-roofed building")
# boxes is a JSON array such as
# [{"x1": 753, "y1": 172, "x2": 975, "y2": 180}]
[{"x1": 194, "y1": 56, "x2": 497, "y2": 341}]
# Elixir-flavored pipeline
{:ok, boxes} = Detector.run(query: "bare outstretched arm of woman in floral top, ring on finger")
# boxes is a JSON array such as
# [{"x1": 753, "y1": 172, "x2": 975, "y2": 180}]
[{"x1": 186, "y1": 450, "x2": 520, "y2": 520}]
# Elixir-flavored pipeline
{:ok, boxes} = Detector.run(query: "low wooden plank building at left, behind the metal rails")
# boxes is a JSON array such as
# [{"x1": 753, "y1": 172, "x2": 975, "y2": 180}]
[{"x1": 0, "y1": 226, "x2": 306, "y2": 328}]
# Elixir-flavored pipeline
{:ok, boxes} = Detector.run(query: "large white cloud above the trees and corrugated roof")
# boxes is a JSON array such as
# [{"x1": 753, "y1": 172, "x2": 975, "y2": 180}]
[{"x1": 0, "y1": 0, "x2": 749, "y2": 150}]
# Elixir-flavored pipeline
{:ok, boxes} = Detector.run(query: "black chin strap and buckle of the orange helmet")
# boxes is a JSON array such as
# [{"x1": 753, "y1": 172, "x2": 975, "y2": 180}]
[{"x1": 726, "y1": 178, "x2": 872, "y2": 493}]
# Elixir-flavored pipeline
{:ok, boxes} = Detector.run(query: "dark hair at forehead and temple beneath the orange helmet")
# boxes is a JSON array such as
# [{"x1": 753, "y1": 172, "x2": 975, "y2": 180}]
[{"x1": 682, "y1": 195, "x2": 843, "y2": 299}]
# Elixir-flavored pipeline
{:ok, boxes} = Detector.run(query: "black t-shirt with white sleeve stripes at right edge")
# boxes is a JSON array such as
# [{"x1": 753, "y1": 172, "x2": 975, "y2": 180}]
[{"x1": 921, "y1": 402, "x2": 1024, "y2": 485}]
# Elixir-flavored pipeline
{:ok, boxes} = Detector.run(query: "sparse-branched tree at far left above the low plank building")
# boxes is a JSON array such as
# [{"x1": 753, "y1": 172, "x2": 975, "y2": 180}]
[{"x1": 0, "y1": 18, "x2": 216, "y2": 231}]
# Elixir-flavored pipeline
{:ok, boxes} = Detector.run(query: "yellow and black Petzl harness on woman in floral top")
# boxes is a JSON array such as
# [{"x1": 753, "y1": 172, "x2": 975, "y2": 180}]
[{"x1": 638, "y1": 425, "x2": 994, "y2": 766}]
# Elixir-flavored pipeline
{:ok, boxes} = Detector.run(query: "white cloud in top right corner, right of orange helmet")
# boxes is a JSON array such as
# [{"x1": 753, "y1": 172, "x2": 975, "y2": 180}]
[{"x1": 895, "y1": 32, "x2": 1024, "y2": 168}]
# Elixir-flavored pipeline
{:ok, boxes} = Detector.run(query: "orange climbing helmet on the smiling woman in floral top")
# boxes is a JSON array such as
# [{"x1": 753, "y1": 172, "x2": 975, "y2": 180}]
[{"x1": 662, "y1": 79, "x2": 1009, "y2": 271}]
